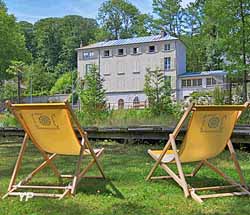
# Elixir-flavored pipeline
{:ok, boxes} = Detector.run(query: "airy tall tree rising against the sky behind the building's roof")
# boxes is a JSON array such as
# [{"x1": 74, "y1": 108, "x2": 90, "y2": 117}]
[{"x1": 98, "y1": 0, "x2": 149, "y2": 39}]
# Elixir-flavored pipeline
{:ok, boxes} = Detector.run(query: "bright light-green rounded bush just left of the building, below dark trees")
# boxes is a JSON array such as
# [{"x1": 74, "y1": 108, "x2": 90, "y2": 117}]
[{"x1": 50, "y1": 71, "x2": 77, "y2": 95}]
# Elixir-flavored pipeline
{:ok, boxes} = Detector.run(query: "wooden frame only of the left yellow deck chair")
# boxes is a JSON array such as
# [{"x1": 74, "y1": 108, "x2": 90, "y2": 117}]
[{"x1": 3, "y1": 102, "x2": 105, "y2": 200}]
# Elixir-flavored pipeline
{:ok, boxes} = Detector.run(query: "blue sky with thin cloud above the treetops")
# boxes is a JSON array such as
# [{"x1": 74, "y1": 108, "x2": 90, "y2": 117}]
[{"x1": 4, "y1": 0, "x2": 194, "y2": 23}]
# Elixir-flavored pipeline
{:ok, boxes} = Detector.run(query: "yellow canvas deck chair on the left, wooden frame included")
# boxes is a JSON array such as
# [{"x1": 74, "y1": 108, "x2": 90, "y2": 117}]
[{"x1": 3, "y1": 102, "x2": 105, "y2": 199}]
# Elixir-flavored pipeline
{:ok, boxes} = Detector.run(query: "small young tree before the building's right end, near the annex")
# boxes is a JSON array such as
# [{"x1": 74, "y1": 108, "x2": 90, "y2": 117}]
[{"x1": 144, "y1": 68, "x2": 172, "y2": 115}]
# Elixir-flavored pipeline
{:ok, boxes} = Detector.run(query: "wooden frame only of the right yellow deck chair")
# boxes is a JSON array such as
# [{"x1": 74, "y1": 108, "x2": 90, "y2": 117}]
[{"x1": 146, "y1": 102, "x2": 250, "y2": 203}]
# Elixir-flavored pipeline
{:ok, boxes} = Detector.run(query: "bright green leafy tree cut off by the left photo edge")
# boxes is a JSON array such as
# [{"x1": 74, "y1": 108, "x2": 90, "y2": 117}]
[{"x1": 0, "y1": 5, "x2": 31, "y2": 84}]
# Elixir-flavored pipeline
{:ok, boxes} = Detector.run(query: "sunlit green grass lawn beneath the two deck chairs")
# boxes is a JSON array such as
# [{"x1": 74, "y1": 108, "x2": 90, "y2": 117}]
[{"x1": 0, "y1": 140, "x2": 250, "y2": 215}]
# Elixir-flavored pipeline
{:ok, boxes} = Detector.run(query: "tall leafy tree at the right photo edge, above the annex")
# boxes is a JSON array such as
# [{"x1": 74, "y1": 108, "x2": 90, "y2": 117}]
[{"x1": 204, "y1": 0, "x2": 250, "y2": 101}]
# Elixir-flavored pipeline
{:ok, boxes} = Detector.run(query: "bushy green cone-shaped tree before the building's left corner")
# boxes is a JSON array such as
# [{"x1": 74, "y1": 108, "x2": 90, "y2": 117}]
[{"x1": 78, "y1": 66, "x2": 108, "y2": 124}]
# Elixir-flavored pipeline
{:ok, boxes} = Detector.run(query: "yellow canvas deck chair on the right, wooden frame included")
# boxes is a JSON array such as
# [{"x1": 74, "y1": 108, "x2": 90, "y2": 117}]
[{"x1": 147, "y1": 103, "x2": 250, "y2": 203}]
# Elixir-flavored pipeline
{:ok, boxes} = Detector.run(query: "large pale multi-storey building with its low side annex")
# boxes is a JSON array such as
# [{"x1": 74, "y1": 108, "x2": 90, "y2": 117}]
[{"x1": 77, "y1": 35, "x2": 228, "y2": 109}]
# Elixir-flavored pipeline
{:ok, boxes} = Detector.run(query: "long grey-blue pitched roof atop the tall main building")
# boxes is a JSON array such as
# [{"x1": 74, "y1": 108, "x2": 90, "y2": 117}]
[{"x1": 78, "y1": 35, "x2": 178, "y2": 50}]
